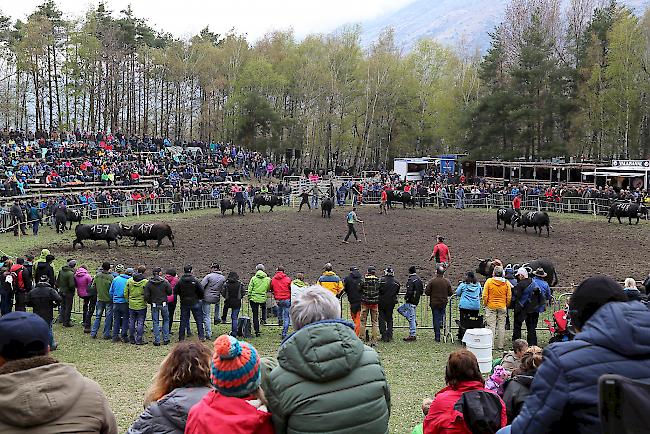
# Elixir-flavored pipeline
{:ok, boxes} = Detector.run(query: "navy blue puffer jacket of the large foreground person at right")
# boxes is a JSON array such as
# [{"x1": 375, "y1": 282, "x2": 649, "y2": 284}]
[{"x1": 511, "y1": 301, "x2": 650, "y2": 434}]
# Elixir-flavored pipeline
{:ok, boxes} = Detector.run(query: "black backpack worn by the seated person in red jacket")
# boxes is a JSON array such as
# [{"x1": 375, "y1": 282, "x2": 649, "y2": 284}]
[{"x1": 454, "y1": 390, "x2": 502, "y2": 434}]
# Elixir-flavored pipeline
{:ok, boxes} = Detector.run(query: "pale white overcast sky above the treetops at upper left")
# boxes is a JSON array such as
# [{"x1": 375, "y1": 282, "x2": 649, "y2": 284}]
[{"x1": 0, "y1": 0, "x2": 413, "y2": 40}]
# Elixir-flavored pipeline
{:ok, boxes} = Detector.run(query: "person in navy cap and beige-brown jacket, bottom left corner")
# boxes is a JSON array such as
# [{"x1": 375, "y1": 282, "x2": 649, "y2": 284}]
[{"x1": 0, "y1": 312, "x2": 118, "y2": 434}]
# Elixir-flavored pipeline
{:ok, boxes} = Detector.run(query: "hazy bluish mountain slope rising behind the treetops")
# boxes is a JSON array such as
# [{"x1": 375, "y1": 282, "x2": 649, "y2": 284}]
[{"x1": 361, "y1": 0, "x2": 650, "y2": 51}]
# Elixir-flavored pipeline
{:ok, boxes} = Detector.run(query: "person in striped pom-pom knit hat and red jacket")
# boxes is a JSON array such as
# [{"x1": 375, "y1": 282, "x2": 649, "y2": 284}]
[{"x1": 185, "y1": 335, "x2": 275, "y2": 434}]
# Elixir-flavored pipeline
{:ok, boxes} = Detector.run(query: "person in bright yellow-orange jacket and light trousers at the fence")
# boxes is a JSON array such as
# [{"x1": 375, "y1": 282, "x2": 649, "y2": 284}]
[{"x1": 481, "y1": 265, "x2": 512, "y2": 351}]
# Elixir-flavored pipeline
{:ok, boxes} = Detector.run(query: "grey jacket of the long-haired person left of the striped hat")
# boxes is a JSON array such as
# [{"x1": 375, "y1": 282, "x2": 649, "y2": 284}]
[{"x1": 127, "y1": 387, "x2": 210, "y2": 434}]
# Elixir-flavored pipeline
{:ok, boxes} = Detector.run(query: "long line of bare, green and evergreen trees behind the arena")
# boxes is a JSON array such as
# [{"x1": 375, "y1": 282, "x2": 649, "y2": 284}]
[{"x1": 0, "y1": 0, "x2": 650, "y2": 169}]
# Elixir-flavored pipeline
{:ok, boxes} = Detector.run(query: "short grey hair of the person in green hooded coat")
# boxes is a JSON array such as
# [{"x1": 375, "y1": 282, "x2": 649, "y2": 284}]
[{"x1": 289, "y1": 285, "x2": 341, "y2": 330}]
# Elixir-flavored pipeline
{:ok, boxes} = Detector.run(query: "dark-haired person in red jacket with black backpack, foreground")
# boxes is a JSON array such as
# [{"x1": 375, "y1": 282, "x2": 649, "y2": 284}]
[{"x1": 423, "y1": 349, "x2": 508, "y2": 434}]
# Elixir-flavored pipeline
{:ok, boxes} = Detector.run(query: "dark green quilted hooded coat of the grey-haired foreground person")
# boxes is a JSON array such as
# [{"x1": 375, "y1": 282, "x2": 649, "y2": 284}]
[{"x1": 262, "y1": 320, "x2": 390, "y2": 434}]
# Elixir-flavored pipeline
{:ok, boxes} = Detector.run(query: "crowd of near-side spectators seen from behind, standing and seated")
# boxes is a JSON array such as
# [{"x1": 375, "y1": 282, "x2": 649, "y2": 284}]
[{"x1": 0, "y1": 249, "x2": 650, "y2": 434}]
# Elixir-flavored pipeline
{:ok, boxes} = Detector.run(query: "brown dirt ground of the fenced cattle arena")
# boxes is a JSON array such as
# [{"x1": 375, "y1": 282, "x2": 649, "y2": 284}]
[{"x1": 53, "y1": 206, "x2": 650, "y2": 286}]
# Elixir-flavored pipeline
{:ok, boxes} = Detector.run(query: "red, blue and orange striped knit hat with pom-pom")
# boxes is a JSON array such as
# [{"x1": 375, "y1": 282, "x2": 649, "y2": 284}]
[{"x1": 210, "y1": 335, "x2": 261, "y2": 398}]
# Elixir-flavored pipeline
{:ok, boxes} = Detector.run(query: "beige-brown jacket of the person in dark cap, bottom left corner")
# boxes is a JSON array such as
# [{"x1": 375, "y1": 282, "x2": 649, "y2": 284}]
[{"x1": 0, "y1": 356, "x2": 118, "y2": 434}]
